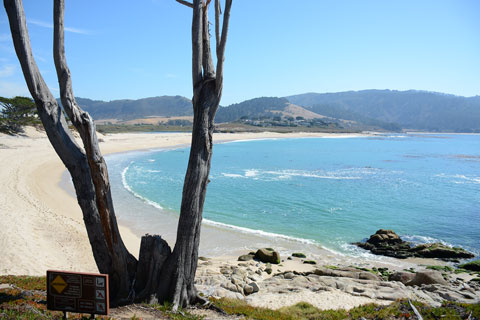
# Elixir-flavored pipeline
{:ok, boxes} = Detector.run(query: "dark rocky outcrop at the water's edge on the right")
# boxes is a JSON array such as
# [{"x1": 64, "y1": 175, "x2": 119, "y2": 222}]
[{"x1": 354, "y1": 229, "x2": 474, "y2": 261}]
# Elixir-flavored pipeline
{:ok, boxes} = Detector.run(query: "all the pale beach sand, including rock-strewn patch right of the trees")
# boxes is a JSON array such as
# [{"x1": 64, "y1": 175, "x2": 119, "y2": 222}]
[{"x1": 0, "y1": 128, "x2": 478, "y2": 309}]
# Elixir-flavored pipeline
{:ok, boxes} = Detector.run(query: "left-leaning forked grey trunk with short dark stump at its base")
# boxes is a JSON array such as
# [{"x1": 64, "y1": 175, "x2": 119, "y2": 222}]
[{"x1": 4, "y1": 0, "x2": 170, "y2": 305}]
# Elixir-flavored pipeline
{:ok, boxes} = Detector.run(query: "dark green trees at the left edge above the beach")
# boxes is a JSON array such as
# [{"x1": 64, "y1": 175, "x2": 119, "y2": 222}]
[{"x1": 0, "y1": 97, "x2": 40, "y2": 134}]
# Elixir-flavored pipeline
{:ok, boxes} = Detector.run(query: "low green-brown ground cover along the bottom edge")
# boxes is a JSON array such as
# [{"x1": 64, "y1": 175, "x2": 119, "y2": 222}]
[{"x1": 0, "y1": 276, "x2": 480, "y2": 320}]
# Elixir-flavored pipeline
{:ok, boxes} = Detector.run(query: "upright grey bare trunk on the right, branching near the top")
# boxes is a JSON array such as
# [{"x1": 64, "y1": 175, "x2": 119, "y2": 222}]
[{"x1": 158, "y1": 0, "x2": 232, "y2": 309}]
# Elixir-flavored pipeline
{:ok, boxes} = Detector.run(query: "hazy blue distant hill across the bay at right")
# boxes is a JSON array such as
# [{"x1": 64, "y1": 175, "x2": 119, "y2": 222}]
[{"x1": 286, "y1": 90, "x2": 480, "y2": 132}]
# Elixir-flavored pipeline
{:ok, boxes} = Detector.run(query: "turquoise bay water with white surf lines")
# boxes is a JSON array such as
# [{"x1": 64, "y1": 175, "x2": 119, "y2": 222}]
[{"x1": 113, "y1": 135, "x2": 480, "y2": 254}]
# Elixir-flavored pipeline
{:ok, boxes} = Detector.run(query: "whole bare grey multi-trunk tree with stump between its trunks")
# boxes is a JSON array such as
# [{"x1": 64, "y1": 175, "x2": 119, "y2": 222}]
[{"x1": 4, "y1": 0, "x2": 232, "y2": 309}]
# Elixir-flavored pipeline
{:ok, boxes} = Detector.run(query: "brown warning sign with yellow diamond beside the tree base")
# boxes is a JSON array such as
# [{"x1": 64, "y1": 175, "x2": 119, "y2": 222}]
[{"x1": 47, "y1": 270, "x2": 109, "y2": 315}]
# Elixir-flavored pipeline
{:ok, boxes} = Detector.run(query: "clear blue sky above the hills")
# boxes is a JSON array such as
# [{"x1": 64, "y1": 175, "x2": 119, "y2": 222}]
[{"x1": 0, "y1": 0, "x2": 480, "y2": 105}]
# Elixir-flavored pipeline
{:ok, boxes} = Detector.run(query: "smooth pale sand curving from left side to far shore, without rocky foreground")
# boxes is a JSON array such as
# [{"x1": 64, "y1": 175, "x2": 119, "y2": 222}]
[{"x1": 0, "y1": 128, "x2": 364, "y2": 275}]
